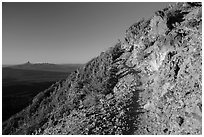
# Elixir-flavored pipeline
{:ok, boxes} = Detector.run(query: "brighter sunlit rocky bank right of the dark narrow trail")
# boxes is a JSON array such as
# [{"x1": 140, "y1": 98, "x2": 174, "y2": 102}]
[{"x1": 124, "y1": 4, "x2": 202, "y2": 134}]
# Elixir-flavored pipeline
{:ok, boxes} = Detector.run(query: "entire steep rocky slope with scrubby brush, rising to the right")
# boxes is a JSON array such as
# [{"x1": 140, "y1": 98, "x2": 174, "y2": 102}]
[{"x1": 3, "y1": 3, "x2": 202, "y2": 135}]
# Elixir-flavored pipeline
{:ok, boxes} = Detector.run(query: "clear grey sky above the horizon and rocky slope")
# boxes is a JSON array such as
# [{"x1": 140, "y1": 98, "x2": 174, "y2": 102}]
[{"x1": 2, "y1": 2, "x2": 173, "y2": 64}]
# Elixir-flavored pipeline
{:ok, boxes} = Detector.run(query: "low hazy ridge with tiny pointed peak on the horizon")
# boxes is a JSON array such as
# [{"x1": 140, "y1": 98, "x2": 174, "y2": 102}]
[{"x1": 7, "y1": 62, "x2": 82, "y2": 72}]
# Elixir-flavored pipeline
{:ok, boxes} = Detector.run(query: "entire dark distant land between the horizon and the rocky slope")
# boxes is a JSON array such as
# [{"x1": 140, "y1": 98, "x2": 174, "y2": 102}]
[{"x1": 2, "y1": 63, "x2": 80, "y2": 121}]
